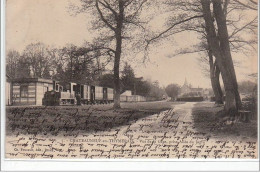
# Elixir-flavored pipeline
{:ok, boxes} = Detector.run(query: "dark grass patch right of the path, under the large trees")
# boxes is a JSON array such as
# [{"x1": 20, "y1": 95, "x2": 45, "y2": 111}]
[{"x1": 192, "y1": 103, "x2": 257, "y2": 139}]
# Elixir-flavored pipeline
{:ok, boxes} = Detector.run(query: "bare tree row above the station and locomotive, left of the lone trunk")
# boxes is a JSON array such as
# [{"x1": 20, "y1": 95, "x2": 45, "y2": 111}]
[{"x1": 6, "y1": 43, "x2": 109, "y2": 83}]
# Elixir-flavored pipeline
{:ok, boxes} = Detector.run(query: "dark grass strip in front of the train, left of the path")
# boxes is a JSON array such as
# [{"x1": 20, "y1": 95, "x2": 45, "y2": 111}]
[{"x1": 6, "y1": 102, "x2": 181, "y2": 136}]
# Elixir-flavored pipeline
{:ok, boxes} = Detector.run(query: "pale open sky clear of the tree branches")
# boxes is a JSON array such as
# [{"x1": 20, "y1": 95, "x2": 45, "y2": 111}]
[{"x1": 5, "y1": 0, "x2": 258, "y2": 88}]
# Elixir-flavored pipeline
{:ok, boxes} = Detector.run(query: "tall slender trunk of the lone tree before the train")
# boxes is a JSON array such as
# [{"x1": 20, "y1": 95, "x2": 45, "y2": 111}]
[{"x1": 113, "y1": 1, "x2": 124, "y2": 109}]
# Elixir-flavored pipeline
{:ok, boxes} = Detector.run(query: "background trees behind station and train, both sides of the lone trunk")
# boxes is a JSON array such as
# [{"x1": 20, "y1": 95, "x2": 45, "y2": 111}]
[{"x1": 6, "y1": 43, "x2": 165, "y2": 100}]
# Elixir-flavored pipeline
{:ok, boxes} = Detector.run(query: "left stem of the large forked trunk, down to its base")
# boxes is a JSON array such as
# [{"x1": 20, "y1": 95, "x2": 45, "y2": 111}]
[{"x1": 201, "y1": 0, "x2": 238, "y2": 116}]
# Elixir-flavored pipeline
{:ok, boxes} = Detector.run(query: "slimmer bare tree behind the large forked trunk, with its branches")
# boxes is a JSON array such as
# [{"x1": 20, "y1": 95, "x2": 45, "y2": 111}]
[{"x1": 169, "y1": 0, "x2": 257, "y2": 103}]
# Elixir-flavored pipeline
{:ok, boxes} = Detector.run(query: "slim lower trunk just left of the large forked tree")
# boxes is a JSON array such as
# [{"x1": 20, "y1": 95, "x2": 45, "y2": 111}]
[{"x1": 208, "y1": 50, "x2": 223, "y2": 104}]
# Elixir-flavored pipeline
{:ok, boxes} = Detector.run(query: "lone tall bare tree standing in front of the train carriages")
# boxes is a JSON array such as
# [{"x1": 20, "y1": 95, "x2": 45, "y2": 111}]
[{"x1": 72, "y1": 0, "x2": 150, "y2": 108}]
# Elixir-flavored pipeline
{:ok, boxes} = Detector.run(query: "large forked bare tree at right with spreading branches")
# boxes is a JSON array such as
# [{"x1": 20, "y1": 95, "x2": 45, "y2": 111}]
[{"x1": 147, "y1": 0, "x2": 256, "y2": 115}]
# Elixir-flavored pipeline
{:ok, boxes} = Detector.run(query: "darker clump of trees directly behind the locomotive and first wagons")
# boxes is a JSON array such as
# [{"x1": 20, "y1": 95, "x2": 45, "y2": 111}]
[{"x1": 52, "y1": 43, "x2": 111, "y2": 85}]
